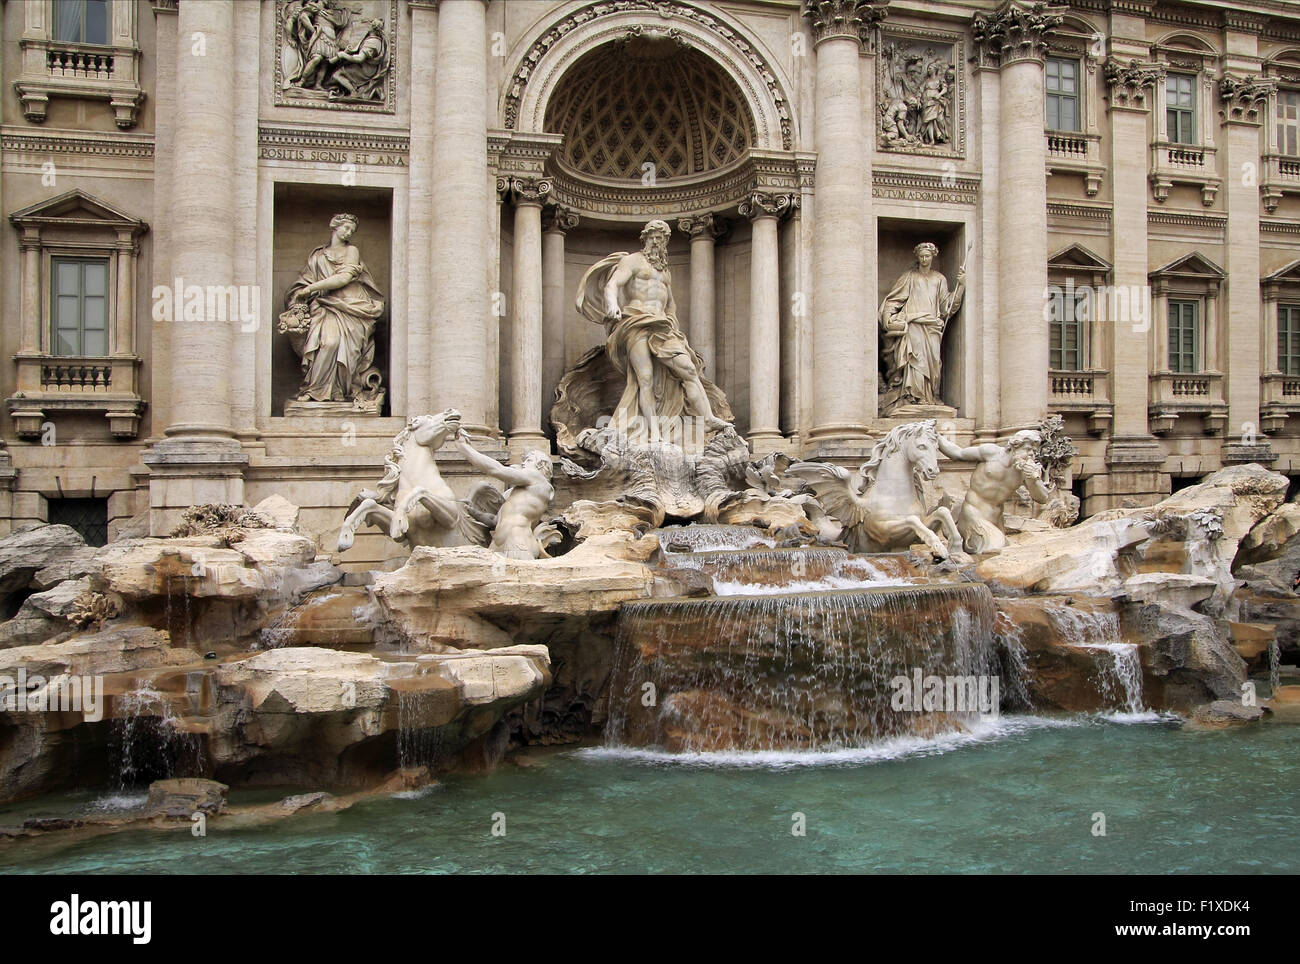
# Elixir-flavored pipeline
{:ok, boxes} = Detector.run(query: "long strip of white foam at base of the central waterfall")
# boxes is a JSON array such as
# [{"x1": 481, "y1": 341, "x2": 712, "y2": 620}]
[{"x1": 585, "y1": 716, "x2": 1088, "y2": 769}]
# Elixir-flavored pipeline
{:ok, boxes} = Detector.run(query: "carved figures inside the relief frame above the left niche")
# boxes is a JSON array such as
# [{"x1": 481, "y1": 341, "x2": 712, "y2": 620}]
[{"x1": 281, "y1": 0, "x2": 393, "y2": 108}]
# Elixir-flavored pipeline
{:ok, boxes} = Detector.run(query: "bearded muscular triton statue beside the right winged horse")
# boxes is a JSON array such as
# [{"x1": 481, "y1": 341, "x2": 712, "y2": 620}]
[{"x1": 939, "y1": 429, "x2": 1053, "y2": 553}]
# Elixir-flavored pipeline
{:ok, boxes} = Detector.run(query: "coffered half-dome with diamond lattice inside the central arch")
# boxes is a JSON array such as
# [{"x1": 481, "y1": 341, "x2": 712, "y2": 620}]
[{"x1": 545, "y1": 36, "x2": 755, "y2": 183}]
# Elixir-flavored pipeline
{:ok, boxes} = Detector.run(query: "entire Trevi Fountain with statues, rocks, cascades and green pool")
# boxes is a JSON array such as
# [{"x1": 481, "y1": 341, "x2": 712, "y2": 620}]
[{"x1": 0, "y1": 214, "x2": 1300, "y2": 872}]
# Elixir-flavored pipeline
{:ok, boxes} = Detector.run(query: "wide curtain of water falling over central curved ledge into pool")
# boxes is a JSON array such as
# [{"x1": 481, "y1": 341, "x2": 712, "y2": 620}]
[{"x1": 606, "y1": 583, "x2": 996, "y2": 752}]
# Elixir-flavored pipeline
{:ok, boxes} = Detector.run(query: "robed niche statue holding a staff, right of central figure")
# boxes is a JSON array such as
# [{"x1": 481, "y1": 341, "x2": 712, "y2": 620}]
[{"x1": 880, "y1": 242, "x2": 966, "y2": 414}]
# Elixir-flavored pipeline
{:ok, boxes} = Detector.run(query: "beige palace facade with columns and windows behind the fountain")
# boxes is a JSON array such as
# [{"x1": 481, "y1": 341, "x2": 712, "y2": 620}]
[{"x1": 0, "y1": 0, "x2": 1300, "y2": 565}]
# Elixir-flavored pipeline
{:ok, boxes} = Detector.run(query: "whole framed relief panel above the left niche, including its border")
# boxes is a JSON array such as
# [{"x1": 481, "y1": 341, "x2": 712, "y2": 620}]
[{"x1": 276, "y1": 0, "x2": 398, "y2": 114}]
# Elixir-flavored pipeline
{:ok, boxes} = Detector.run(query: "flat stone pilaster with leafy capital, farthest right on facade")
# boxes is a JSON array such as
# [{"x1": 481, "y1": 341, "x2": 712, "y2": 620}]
[{"x1": 1206, "y1": 73, "x2": 1275, "y2": 463}]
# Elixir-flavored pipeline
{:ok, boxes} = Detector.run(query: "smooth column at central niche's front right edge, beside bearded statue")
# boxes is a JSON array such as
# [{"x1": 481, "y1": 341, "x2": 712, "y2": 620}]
[{"x1": 740, "y1": 191, "x2": 796, "y2": 455}]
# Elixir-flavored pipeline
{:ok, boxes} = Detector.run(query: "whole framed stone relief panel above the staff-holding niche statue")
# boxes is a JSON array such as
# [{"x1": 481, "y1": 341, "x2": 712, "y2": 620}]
[{"x1": 876, "y1": 30, "x2": 966, "y2": 157}]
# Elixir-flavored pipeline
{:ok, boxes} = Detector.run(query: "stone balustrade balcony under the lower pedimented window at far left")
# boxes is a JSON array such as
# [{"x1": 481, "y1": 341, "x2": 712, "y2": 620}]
[{"x1": 7, "y1": 353, "x2": 144, "y2": 439}]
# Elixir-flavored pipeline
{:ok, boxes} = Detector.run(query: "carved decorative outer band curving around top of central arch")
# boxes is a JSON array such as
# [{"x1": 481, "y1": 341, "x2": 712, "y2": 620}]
[{"x1": 504, "y1": 0, "x2": 794, "y2": 151}]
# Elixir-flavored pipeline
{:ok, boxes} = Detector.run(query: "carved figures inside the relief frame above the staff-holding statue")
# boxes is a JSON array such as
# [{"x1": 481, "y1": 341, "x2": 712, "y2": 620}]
[{"x1": 879, "y1": 42, "x2": 957, "y2": 153}]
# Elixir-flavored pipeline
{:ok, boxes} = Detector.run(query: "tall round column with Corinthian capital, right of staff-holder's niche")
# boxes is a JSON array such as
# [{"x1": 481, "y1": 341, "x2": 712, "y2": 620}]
[{"x1": 972, "y1": 0, "x2": 1065, "y2": 433}]
